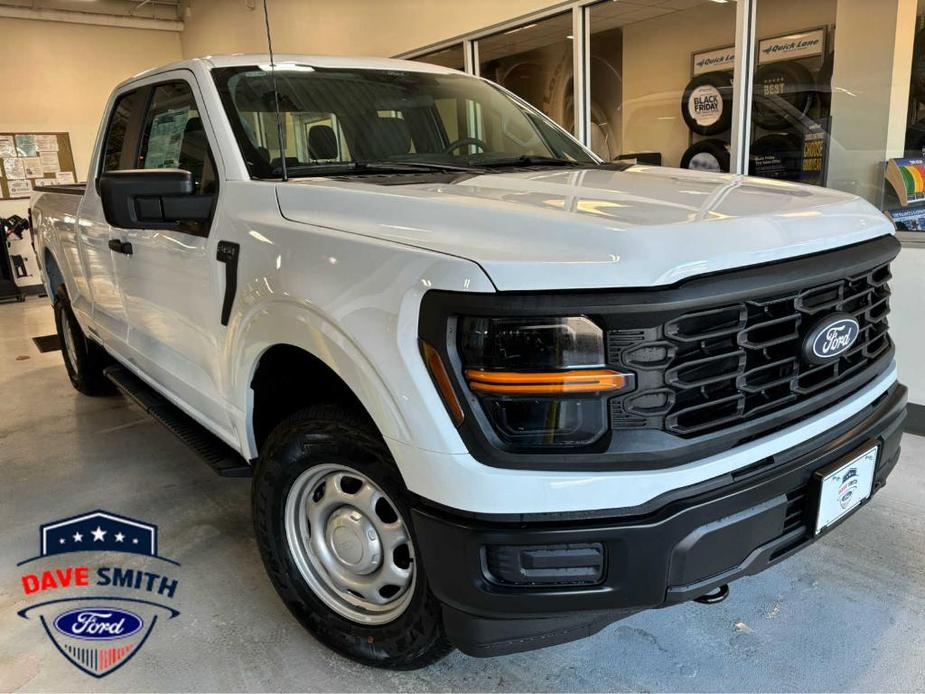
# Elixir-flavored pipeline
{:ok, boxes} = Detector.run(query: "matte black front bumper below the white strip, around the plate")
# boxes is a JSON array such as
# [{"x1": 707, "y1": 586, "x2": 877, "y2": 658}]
[{"x1": 412, "y1": 384, "x2": 906, "y2": 656}]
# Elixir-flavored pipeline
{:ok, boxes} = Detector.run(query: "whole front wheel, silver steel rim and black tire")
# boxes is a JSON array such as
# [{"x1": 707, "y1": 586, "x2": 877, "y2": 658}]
[{"x1": 253, "y1": 405, "x2": 450, "y2": 670}]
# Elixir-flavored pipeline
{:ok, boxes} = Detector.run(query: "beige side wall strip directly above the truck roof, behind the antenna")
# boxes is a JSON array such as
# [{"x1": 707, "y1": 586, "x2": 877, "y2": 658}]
[{"x1": 181, "y1": 0, "x2": 559, "y2": 58}]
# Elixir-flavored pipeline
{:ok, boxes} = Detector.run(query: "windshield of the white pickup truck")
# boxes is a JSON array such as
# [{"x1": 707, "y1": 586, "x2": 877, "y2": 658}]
[{"x1": 213, "y1": 63, "x2": 597, "y2": 178}]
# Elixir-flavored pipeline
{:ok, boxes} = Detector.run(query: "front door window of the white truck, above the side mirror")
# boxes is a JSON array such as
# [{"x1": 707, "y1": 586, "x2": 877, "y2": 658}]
[{"x1": 137, "y1": 82, "x2": 216, "y2": 194}]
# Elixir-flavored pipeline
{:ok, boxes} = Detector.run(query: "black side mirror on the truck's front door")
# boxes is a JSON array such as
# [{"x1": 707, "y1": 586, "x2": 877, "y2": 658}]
[{"x1": 99, "y1": 169, "x2": 214, "y2": 229}]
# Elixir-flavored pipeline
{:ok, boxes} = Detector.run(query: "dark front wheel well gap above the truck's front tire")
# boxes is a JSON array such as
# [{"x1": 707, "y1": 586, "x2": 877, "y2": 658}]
[{"x1": 251, "y1": 345, "x2": 372, "y2": 451}]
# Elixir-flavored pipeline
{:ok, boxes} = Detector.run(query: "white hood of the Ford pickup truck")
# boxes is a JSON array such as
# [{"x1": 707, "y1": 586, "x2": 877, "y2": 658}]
[{"x1": 277, "y1": 166, "x2": 893, "y2": 291}]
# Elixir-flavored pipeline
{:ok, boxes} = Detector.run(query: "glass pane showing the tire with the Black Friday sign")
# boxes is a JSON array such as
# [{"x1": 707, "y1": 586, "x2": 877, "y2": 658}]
[{"x1": 589, "y1": 0, "x2": 736, "y2": 171}]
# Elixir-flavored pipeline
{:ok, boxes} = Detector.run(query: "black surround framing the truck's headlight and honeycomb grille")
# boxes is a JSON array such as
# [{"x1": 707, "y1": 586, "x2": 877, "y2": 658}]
[{"x1": 418, "y1": 235, "x2": 900, "y2": 471}]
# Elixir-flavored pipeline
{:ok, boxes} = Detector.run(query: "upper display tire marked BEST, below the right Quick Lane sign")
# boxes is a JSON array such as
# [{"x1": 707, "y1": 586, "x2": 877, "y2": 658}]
[{"x1": 752, "y1": 60, "x2": 816, "y2": 130}]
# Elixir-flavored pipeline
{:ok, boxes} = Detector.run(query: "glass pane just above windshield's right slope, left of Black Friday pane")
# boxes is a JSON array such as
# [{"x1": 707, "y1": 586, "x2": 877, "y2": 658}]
[{"x1": 478, "y1": 12, "x2": 575, "y2": 132}]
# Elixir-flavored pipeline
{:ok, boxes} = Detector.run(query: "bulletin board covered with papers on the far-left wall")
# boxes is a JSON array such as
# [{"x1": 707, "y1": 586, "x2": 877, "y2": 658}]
[{"x1": 0, "y1": 132, "x2": 77, "y2": 200}]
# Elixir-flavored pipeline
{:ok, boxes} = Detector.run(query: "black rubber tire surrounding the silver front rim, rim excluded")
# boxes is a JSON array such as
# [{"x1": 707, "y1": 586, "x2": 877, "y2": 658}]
[{"x1": 252, "y1": 405, "x2": 452, "y2": 670}]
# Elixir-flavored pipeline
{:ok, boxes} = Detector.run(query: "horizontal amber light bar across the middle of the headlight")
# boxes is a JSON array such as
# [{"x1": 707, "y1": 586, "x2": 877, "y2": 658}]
[{"x1": 466, "y1": 369, "x2": 626, "y2": 395}]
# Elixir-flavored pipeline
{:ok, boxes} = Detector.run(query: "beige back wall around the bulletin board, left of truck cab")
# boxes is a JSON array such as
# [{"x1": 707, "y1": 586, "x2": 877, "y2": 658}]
[{"x1": 0, "y1": 19, "x2": 181, "y2": 207}]
